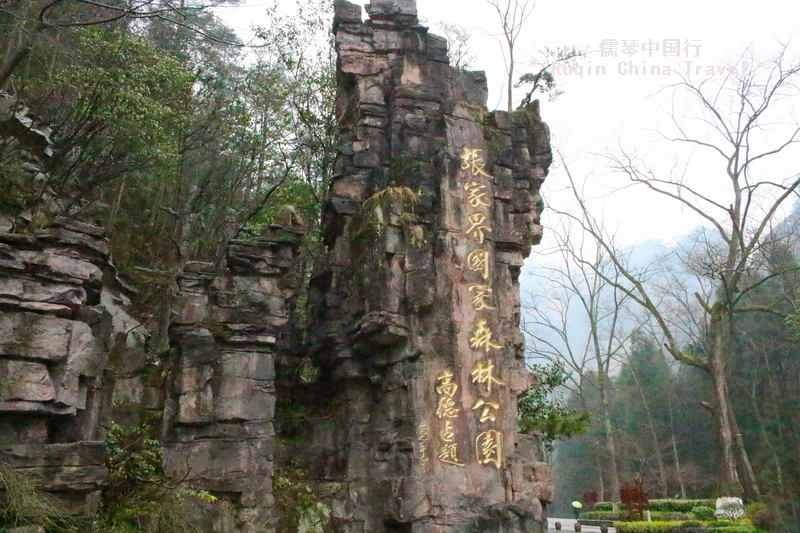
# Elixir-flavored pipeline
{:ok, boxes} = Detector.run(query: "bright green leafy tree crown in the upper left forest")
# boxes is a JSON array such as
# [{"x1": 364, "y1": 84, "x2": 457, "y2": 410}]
[{"x1": 20, "y1": 27, "x2": 194, "y2": 206}]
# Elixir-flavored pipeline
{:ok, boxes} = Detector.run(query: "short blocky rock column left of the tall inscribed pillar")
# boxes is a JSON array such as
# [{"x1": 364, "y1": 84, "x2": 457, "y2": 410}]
[{"x1": 164, "y1": 227, "x2": 302, "y2": 533}]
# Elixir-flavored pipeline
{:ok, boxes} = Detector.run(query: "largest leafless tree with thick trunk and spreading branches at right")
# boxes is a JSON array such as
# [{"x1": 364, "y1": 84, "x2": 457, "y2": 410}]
[{"x1": 552, "y1": 46, "x2": 800, "y2": 498}]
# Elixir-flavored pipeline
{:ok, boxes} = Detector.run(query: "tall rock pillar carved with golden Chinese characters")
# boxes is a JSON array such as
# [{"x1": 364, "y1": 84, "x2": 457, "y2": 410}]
[{"x1": 296, "y1": 0, "x2": 552, "y2": 533}]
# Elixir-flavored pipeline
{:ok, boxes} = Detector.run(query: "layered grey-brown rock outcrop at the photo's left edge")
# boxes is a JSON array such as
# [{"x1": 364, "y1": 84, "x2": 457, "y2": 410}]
[{"x1": 0, "y1": 218, "x2": 144, "y2": 512}]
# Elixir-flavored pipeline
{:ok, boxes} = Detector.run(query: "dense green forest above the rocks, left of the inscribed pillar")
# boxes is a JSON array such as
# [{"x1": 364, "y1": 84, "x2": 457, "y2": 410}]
[{"x1": 0, "y1": 0, "x2": 336, "y2": 344}]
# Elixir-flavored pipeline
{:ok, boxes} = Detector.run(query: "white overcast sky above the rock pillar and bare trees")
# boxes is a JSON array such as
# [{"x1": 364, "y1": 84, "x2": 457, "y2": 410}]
[{"x1": 216, "y1": 0, "x2": 800, "y2": 243}]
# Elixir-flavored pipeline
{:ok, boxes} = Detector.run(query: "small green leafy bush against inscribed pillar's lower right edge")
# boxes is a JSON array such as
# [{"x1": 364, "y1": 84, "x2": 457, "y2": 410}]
[{"x1": 517, "y1": 360, "x2": 589, "y2": 450}]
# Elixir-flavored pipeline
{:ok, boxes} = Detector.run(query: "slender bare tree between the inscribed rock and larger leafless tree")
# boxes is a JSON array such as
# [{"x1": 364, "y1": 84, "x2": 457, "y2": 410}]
[{"x1": 523, "y1": 210, "x2": 632, "y2": 501}]
